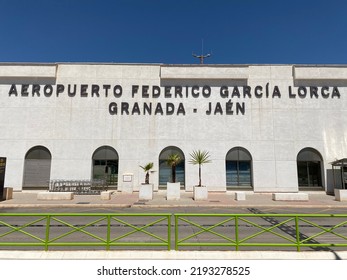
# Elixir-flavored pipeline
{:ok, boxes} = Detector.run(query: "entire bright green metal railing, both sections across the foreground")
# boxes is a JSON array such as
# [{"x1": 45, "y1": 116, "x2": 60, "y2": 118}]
[{"x1": 0, "y1": 213, "x2": 347, "y2": 251}]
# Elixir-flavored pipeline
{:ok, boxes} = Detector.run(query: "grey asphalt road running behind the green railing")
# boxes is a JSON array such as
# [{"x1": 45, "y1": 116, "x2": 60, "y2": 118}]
[{"x1": 0, "y1": 207, "x2": 347, "y2": 251}]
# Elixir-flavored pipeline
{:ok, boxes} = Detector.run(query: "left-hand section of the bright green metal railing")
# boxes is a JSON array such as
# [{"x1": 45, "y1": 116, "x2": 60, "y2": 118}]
[{"x1": 0, "y1": 213, "x2": 172, "y2": 250}]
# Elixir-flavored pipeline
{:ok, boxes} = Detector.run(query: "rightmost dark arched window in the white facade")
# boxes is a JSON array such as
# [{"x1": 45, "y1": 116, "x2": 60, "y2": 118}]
[{"x1": 297, "y1": 148, "x2": 323, "y2": 188}]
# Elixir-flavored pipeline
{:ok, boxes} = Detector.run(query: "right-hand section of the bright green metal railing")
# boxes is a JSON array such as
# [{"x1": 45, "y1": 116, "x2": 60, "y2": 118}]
[{"x1": 174, "y1": 214, "x2": 347, "y2": 251}]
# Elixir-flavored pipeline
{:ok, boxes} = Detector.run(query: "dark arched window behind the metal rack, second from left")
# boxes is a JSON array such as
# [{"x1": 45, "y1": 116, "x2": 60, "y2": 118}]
[{"x1": 92, "y1": 146, "x2": 119, "y2": 186}]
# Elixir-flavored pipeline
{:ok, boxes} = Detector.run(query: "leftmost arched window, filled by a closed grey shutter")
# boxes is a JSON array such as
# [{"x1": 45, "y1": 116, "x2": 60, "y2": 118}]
[{"x1": 23, "y1": 146, "x2": 52, "y2": 189}]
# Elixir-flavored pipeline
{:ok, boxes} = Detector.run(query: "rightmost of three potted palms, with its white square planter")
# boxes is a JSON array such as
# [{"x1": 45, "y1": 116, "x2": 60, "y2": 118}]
[{"x1": 189, "y1": 150, "x2": 211, "y2": 200}]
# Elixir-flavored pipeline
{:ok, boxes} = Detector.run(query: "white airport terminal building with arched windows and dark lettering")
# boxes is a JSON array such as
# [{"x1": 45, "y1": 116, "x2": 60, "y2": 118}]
[{"x1": 0, "y1": 63, "x2": 347, "y2": 193}]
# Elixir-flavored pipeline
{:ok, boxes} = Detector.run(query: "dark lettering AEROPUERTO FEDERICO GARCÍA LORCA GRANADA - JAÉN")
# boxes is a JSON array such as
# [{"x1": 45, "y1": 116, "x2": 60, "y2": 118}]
[{"x1": 8, "y1": 83, "x2": 341, "y2": 115}]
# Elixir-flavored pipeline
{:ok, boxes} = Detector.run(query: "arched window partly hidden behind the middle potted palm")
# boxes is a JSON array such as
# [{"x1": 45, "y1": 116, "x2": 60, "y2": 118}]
[{"x1": 159, "y1": 146, "x2": 185, "y2": 188}]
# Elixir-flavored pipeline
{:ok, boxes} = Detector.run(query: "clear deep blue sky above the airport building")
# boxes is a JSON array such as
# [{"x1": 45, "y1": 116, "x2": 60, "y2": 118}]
[{"x1": 0, "y1": 0, "x2": 347, "y2": 64}]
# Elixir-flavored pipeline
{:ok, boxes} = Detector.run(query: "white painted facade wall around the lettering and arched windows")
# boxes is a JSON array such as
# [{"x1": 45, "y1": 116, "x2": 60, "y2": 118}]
[{"x1": 0, "y1": 64, "x2": 347, "y2": 192}]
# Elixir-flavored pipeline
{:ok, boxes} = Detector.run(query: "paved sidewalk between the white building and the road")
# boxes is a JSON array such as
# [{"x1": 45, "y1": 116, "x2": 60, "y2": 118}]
[{"x1": 0, "y1": 191, "x2": 347, "y2": 209}]
